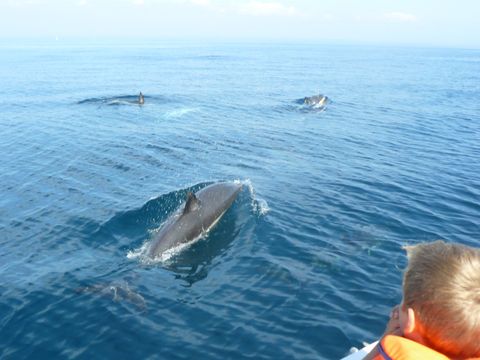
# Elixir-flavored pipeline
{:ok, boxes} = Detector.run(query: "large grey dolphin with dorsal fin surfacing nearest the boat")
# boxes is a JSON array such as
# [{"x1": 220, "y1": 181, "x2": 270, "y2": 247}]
[{"x1": 148, "y1": 182, "x2": 242, "y2": 258}]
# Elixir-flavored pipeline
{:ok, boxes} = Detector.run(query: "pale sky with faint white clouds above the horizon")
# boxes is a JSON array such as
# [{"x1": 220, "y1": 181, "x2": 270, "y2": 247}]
[{"x1": 0, "y1": 0, "x2": 480, "y2": 48}]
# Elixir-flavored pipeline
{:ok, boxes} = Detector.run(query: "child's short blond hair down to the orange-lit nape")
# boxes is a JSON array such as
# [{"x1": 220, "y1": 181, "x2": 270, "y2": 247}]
[{"x1": 403, "y1": 241, "x2": 480, "y2": 358}]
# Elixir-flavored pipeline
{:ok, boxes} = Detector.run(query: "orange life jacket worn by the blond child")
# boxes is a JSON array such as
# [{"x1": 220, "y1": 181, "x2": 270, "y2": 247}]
[{"x1": 374, "y1": 335, "x2": 480, "y2": 360}]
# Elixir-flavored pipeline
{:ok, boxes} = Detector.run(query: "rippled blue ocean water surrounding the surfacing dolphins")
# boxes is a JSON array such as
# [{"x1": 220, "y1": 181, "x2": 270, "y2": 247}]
[{"x1": 0, "y1": 41, "x2": 480, "y2": 359}]
